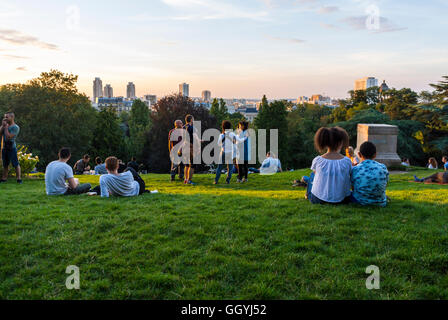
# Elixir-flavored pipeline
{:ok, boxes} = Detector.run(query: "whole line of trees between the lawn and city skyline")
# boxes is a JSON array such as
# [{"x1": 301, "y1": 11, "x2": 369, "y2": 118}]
[{"x1": 0, "y1": 70, "x2": 448, "y2": 172}]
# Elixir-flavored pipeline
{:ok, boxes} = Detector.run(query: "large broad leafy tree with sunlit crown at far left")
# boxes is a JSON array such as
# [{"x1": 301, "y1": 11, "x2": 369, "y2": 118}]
[{"x1": 0, "y1": 70, "x2": 96, "y2": 169}]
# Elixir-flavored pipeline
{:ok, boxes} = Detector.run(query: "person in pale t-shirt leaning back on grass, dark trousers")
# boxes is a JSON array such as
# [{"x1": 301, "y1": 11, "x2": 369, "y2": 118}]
[{"x1": 95, "y1": 157, "x2": 146, "y2": 198}]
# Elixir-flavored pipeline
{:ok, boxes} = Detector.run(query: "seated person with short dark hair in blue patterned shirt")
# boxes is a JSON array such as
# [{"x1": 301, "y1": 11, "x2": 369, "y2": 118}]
[{"x1": 351, "y1": 141, "x2": 389, "y2": 207}]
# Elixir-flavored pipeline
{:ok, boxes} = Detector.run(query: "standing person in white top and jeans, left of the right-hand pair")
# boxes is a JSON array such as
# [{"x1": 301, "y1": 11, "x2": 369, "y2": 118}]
[{"x1": 213, "y1": 120, "x2": 247, "y2": 184}]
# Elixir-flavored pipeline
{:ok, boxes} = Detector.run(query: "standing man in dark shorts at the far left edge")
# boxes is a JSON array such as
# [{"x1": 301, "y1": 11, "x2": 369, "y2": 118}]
[{"x1": 0, "y1": 112, "x2": 22, "y2": 183}]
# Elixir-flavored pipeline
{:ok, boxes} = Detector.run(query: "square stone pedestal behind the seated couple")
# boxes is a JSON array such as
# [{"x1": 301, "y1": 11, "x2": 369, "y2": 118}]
[{"x1": 356, "y1": 123, "x2": 401, "y2": 167}]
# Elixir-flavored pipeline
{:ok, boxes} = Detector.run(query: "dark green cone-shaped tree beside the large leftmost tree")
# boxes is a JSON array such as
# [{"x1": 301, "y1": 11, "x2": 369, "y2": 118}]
[{"x1": 90, "y1": 108, "x2": 127, "y2": 161}]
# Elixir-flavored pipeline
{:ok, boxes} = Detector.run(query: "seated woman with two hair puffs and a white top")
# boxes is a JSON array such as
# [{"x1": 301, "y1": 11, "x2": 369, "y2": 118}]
[{"x1": 304, "y1": 127, "x2": 352, "y2": 204}]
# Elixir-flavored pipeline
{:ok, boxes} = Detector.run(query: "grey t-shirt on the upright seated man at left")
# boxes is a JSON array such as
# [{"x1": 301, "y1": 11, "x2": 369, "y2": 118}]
[{"x1": 45, "y1": 161, "x2": 73, "y2": 196}]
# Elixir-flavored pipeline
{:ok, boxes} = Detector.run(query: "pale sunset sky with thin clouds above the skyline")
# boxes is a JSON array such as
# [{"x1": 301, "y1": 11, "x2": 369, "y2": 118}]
[{"x1": 0, "y1": 0, "x2": 448, "y2": 99}]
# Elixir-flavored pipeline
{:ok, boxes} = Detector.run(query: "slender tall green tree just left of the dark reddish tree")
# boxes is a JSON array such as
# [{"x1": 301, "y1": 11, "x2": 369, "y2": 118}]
[{"x1": 127, "y1": 99, "x2": 151, "y2": 161}]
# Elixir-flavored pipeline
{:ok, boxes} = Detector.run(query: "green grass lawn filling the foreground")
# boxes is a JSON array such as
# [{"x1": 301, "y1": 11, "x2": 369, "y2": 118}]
[{"x1": 0, "y1": 170, "x2": 448, "y2": 299}]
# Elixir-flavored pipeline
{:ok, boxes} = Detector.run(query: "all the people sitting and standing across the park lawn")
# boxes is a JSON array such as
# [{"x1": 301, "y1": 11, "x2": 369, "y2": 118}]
[{"x1": 0, "y1": 112, "x2": 448, "y2": 206}]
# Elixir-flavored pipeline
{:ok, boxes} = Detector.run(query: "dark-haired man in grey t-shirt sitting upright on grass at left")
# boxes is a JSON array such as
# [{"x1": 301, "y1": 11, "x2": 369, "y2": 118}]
[{"x1": 45, "y1": 148, "x2": 91, "y2": 196}]
